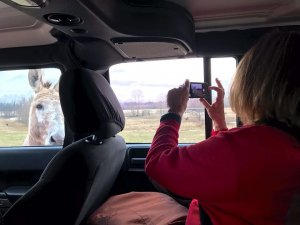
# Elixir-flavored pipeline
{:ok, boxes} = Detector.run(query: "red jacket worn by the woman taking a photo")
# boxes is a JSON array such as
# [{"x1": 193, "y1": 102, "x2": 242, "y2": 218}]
[{"x1": 146, "y1": 115, "x2": 300, "y2": 225}]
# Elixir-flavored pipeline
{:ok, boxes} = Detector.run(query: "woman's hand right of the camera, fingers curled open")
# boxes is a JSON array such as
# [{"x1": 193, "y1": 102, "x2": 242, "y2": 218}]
[{"x1": 200, "y1": 78, "x2": 227, "y2": 131}]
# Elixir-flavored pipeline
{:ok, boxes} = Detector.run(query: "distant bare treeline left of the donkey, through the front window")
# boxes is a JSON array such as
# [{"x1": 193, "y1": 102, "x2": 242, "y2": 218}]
[{"x1": 0, "y1": 98, "x2": 32, "y2": 125}]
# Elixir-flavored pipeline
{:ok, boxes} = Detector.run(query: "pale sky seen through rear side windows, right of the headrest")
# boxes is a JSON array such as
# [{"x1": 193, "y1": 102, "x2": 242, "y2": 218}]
[{"x1": 110, "y1": 58, "x2": 236, "y2": 102}]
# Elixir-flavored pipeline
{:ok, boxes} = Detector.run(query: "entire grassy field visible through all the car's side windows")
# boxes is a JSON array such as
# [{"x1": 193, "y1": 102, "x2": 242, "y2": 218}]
[{"x1": 0, "y1": 109, "x2": 236, "y2": 146}]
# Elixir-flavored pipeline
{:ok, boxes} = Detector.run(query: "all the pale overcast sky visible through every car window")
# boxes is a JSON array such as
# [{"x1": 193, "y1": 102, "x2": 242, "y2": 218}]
[{"x1": 0, "y1": 58, "x2": 235, "y2": 102}]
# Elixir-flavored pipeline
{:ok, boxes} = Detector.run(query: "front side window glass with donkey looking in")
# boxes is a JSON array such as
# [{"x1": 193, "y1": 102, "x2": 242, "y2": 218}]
[{"x1": 0, "y1": 68, "x2": 64, "y2": 147}]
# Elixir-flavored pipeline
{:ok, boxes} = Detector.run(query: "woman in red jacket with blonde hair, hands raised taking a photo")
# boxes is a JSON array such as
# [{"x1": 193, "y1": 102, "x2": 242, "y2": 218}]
[{"x1": 146, "y1": 32, "x2": 300, "y2": 225}]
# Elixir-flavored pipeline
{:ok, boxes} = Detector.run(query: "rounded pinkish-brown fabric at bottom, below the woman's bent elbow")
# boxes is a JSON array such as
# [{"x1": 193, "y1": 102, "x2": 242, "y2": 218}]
[{"x1": 87, "y1": 192, "x2": 188, "y2": 225}]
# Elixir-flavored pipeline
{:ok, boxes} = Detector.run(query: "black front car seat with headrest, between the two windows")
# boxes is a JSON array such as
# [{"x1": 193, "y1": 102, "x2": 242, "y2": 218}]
[{"x1": 3, "y1": 69, "x2": 126, "y2": 225}]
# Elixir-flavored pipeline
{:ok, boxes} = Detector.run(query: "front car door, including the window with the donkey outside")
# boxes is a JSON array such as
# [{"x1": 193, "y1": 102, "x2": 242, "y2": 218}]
[{"x1": 0, "y1": 68, "x2": 64, "y2": 214}]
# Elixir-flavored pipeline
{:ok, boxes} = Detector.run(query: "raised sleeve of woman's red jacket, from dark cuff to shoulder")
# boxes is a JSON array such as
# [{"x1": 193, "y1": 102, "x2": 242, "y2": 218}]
[{"x1": 145, "y1": 115, "x2": 237, "y2": 201}]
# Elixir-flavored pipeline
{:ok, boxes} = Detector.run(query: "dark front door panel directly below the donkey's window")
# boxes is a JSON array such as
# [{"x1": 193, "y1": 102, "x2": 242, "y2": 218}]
[{"x1": 0, "y1": 146, "x2": 62, "y2": 214}]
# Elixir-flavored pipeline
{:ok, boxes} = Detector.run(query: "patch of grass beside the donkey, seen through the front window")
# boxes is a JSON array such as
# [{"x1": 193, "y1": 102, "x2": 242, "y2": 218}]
[{"x1": 0, "y1": 118, "x2": 27, "y2": 147}]
